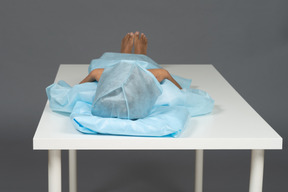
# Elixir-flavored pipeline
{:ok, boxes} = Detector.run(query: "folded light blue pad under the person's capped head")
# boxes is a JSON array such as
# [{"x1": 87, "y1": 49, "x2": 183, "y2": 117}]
[{"x1": 70, "y1": 101, "x2": 189, "y2": 137}]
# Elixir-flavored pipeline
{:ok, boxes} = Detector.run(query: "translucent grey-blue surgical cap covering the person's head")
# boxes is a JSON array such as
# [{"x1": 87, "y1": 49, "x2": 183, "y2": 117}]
[{"x1": 92, "y1": 60, "x2": 162, "y2": 119}]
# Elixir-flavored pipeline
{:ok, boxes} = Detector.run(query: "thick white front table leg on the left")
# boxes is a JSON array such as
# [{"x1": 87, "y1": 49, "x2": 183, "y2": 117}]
[{"x1": 48, "y1": 150, "x2": 62, "y2": 192}]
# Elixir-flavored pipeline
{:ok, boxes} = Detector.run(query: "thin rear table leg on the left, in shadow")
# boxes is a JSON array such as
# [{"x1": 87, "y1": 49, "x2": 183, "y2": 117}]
[{"x1": 69, "y1": 150, "x2": 77, "y2": 192}]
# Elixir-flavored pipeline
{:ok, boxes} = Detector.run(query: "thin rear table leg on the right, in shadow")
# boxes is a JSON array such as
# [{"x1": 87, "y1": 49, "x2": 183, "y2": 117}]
[{"x1": 195, "y1": 150, "x2": 204, "y2": 192}]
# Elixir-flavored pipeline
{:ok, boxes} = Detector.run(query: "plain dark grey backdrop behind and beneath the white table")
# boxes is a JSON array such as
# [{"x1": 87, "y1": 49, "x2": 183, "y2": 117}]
[{"x1": 0, "y1": 0, "x2": 288, "y2": 192}]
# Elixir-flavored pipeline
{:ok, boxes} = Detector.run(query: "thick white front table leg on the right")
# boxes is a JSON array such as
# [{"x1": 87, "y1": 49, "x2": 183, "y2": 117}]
[{"x1": 249, "y1": 150, "x2": 264, "y2": 192}]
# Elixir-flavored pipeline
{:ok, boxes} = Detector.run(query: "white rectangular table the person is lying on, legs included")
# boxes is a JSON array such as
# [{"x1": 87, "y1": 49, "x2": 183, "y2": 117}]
[{"x1": 33, "y1": 64, "x2": 282, "y2": 192}]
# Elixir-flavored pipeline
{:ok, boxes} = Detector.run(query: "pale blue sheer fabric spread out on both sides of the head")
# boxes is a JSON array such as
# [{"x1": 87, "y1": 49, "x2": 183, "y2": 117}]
[{"x1": 46, "y1": 80, "x2": 214, "y2": 117}]
